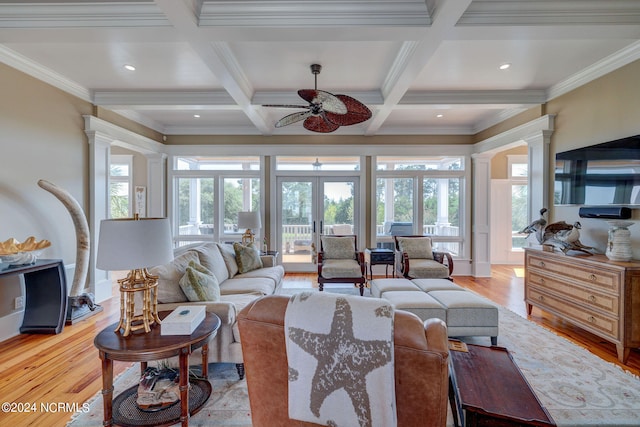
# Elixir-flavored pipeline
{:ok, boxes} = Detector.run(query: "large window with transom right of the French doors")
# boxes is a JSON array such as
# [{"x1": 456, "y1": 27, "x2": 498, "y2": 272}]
[{"x1": 376, "y1": 156, "x2": 465, "y2": 255}]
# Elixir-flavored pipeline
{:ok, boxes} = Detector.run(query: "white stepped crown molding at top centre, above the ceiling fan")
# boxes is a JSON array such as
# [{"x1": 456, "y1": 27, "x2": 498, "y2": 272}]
[{"x1": 198, "y1": 0, "x2": 432, "y2": 27}]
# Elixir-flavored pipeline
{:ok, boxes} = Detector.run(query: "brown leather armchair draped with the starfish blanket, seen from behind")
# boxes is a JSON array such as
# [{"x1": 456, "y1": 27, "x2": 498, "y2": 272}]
[{"x1": 238, "y1": 295, "x2": 449, "y2": 427}]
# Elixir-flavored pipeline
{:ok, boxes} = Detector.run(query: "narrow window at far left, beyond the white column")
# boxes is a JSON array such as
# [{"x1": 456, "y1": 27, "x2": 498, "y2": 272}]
[{"x1": 109, "y1": 155, "x2": 133, "y2": 218}]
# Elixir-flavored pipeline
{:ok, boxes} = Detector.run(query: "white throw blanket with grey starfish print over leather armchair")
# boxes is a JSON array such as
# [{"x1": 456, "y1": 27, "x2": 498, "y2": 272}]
[{"x1": 284, "y1": 292, "x2": 397, "y2": 427}]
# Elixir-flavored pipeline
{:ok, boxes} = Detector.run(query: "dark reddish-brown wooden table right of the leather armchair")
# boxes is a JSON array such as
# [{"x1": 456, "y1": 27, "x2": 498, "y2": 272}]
[{"x1": 449, "y1": 344, "x2": 555, "y2": 427}]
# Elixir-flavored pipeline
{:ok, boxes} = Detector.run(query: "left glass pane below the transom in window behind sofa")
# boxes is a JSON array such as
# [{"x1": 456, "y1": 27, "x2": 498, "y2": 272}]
[{"x1": 176, "y1": 178, "x2": 214, "y2": 236}]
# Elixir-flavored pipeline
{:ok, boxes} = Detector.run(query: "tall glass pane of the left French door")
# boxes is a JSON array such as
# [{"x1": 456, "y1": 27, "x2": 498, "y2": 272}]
[{"x1": 280, "y1": 181, "x2": 313, "y2": 263}]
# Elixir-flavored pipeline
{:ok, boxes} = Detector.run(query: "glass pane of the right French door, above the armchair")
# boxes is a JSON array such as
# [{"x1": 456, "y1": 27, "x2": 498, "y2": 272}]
[{"x1": 322, "y1": 181, "x2": 355, "y2": 234}]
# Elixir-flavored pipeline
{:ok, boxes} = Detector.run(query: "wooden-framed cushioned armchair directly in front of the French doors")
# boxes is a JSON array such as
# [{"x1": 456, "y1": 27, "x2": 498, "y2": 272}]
[{"x1": 318, "y1": 235, "x2": 367, "y2": 296}]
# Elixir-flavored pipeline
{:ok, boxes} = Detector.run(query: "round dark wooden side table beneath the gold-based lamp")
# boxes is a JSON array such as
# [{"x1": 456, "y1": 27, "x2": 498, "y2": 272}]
[{"x1": 93, "y1": 311, "x2": 220, "y2": 426}]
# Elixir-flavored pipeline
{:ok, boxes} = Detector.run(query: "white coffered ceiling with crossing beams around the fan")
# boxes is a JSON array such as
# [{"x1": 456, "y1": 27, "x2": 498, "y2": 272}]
[{"x1": 0, "y1": 0, "x2": 640, "y2": 135}]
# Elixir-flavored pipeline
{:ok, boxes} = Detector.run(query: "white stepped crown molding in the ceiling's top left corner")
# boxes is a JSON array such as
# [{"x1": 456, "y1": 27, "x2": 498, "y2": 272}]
[{"x1": 0, "y1": 1, "x2": 171, "y2": 28}]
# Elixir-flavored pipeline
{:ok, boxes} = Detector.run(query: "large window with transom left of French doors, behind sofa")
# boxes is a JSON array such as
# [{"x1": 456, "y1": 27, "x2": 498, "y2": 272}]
[{"x1": 171, "y1": 156, "x2": 262, "y2": 246}]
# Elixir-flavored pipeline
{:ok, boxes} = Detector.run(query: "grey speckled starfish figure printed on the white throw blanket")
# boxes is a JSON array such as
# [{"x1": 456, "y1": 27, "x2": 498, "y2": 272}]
[{"x1": 289, "y1": 298, "x2": 392, "y2": 427}]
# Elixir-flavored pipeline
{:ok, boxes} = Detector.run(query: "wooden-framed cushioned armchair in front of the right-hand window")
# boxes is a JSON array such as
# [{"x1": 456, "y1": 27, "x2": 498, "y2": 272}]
[{"x1": 394, "y1": 236, "x2": 453, "y2": 280}]
